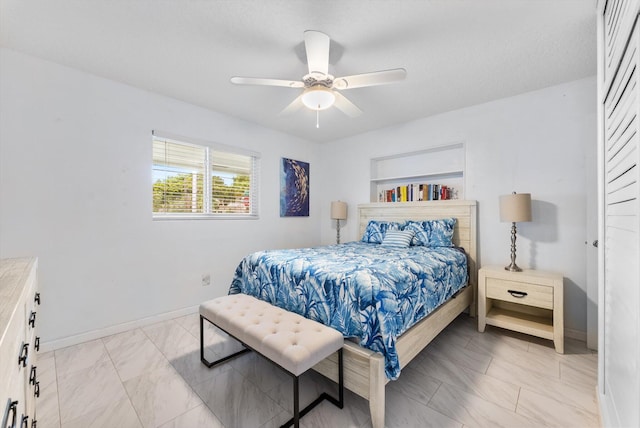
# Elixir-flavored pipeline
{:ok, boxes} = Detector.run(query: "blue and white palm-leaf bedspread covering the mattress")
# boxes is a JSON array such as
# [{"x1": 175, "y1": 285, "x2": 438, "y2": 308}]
[{"x1": 229, "y1": 242, "x2": 467, "y2": 379}]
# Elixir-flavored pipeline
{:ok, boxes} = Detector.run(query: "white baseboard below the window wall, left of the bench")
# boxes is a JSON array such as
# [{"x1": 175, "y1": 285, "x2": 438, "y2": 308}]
[{"x1": 40, "y1": 305, "x2": 199, "y2": 352}]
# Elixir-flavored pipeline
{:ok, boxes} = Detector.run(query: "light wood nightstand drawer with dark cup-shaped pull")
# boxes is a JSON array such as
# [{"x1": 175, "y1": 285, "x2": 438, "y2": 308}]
[{"x1": 486, "y1": 278, "x2": 553, "y2": 309}]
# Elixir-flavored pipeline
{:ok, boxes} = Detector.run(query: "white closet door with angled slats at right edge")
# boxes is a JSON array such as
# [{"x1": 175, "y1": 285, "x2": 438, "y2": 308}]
[{"x1": 600, "y1": 1, "x2": 640, "y2": 426}]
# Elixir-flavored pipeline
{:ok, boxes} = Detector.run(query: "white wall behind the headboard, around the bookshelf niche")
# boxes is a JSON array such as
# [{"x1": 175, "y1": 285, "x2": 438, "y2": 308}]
[{"x1": 321, "y1": 77, "x2": 596, "y2": 332}]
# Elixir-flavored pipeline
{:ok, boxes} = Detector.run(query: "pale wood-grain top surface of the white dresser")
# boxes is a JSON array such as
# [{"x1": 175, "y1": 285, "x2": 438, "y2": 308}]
[{"x1": 0, "y1": 257, "x2": 38, "y2": 341}]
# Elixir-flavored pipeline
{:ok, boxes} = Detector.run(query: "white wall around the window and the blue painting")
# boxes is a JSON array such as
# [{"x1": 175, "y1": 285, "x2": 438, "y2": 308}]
[{"x1": 0, "y1": 49, "x2": 320, "y2": 342}]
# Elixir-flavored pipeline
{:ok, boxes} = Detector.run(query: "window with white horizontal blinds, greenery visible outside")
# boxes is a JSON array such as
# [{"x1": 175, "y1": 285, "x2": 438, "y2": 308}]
[{"x1": 153, "y1": 131, "x2": 259, "y2": 218}]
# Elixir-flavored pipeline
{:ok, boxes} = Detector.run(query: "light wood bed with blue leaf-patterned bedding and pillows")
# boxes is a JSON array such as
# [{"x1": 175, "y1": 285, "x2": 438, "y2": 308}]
[{"x1": 230, "y1": 201, "x2": 477, "y2": 427}]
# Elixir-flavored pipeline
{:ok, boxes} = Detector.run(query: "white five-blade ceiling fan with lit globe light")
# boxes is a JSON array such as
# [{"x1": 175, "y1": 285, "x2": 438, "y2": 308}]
[{"x1": 231, "y1": 30, "x2": 407, "y2": 127}]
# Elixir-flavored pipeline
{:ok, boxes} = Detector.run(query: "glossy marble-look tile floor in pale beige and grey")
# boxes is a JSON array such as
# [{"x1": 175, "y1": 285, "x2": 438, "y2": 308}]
[{"x1": 37, "y1": 314, "x2": 600, "y2": 428}]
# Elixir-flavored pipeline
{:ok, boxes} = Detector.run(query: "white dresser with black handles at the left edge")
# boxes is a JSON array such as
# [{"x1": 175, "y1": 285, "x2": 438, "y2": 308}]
[{"x1": 0, "y1": 258, "x2": 40, "y2": 428}]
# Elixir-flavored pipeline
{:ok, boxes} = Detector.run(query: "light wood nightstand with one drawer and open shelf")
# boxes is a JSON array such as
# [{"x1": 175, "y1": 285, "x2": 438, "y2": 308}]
[{"x1": 478, "y1": 266, "x2": 564, "y2": 354}]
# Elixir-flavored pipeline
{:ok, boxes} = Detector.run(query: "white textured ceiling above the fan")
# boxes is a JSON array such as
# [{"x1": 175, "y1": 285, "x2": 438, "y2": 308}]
[{"x1": 0, "y1": 0, "x2": 596, "y2": 142}]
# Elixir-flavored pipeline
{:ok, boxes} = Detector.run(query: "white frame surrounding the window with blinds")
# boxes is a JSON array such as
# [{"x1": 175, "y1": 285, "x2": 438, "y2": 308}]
[{"x1": 151, "y1": 130, "x2": 261, "y2": 220}]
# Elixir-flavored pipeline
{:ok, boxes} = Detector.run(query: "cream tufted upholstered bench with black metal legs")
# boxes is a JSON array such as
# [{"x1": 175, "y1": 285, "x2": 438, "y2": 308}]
[{"x1": 200, "y1": 294, "x2": 344, "y2": 427}]
